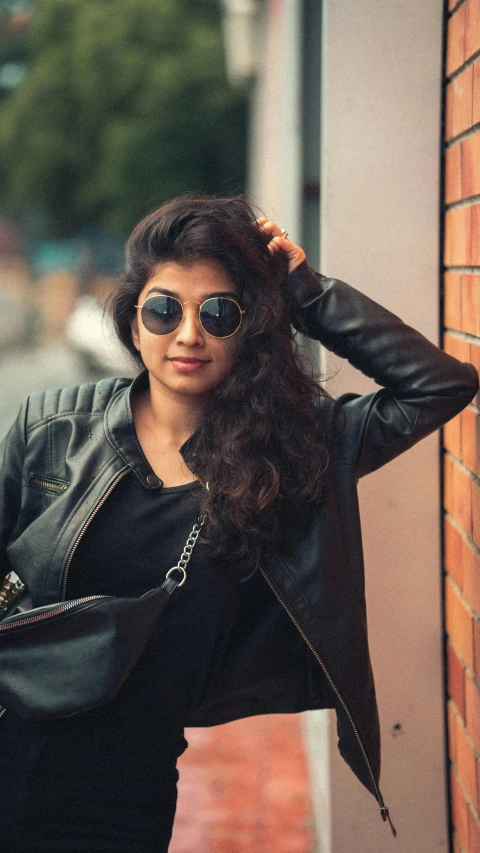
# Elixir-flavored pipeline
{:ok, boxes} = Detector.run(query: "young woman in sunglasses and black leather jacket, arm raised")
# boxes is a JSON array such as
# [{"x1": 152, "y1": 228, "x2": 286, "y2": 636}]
[{"x1": 0, "y1": 197, "x2": 478, "y2": 853}]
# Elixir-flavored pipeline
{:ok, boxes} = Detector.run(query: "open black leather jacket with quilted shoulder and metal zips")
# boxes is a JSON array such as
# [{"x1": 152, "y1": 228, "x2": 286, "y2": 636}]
[{"x1": 0, "y1": 262, "x2": 478, "y2": 832}]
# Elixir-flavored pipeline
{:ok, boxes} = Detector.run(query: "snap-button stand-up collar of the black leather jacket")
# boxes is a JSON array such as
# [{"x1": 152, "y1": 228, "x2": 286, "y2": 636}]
[{"x1": 104, "y1": 370, "x2": 194, "y2": 491}]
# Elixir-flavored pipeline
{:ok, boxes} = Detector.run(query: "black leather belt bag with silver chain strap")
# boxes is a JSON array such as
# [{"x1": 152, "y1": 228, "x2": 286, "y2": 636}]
[{"x1": 0, "y1": 518, "x2": 204, "y2": 719}]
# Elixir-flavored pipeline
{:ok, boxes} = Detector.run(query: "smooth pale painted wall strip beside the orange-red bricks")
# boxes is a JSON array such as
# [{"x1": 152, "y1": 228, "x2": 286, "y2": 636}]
[{"x1": 307, "y1": 0, "x2": 448, "y2": 853}]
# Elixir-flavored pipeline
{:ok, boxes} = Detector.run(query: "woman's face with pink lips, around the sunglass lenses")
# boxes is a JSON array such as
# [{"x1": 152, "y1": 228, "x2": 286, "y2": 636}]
[{"x1": 132, "y1": 260, "x2": 238, "y2": 401}]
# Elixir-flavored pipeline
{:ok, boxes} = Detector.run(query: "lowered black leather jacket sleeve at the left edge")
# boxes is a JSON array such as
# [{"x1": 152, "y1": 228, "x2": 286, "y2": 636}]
[{"x1": 0, "y1": 400, "x2": 28, "y2": 581}]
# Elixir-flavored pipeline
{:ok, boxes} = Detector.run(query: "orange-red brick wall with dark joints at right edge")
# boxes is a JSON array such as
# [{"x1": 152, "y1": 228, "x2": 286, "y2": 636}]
[{"x1": 444, "y1": 0, "x2": 480, "y2": 853}]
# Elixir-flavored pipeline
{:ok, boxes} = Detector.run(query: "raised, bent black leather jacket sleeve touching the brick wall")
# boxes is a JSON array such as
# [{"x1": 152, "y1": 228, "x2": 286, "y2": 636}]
[{"x1": 286, "y1": 261, "x2": 478, "y2": 477}]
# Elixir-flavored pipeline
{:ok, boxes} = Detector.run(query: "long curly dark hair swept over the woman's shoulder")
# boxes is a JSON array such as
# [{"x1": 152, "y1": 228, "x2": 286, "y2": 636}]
[{"x1": 112, "y1": 195, "x2": 330, "y2": 574}]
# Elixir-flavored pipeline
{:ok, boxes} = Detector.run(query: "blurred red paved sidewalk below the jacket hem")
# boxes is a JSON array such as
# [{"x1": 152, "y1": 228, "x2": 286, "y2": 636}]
[{"x1": 170, "y1": 714, "x2": 315, "y2": 853}]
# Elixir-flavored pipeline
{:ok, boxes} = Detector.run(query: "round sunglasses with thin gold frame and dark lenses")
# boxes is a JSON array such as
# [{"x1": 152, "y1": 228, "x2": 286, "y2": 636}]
[{"x1": 135, "y1": 294, "x2": 246, "y2": 338}]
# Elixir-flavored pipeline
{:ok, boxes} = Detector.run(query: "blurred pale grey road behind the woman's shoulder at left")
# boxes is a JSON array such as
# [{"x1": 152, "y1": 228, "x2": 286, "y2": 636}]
[{"x1": 0, "y1": 342, "x2": 107, "y2": 438}]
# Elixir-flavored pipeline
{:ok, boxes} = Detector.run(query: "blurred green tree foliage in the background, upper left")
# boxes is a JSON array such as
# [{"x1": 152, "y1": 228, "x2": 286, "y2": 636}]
[{"x1": 0, "y1": 0, "x2": 246, "y2": 235}]
